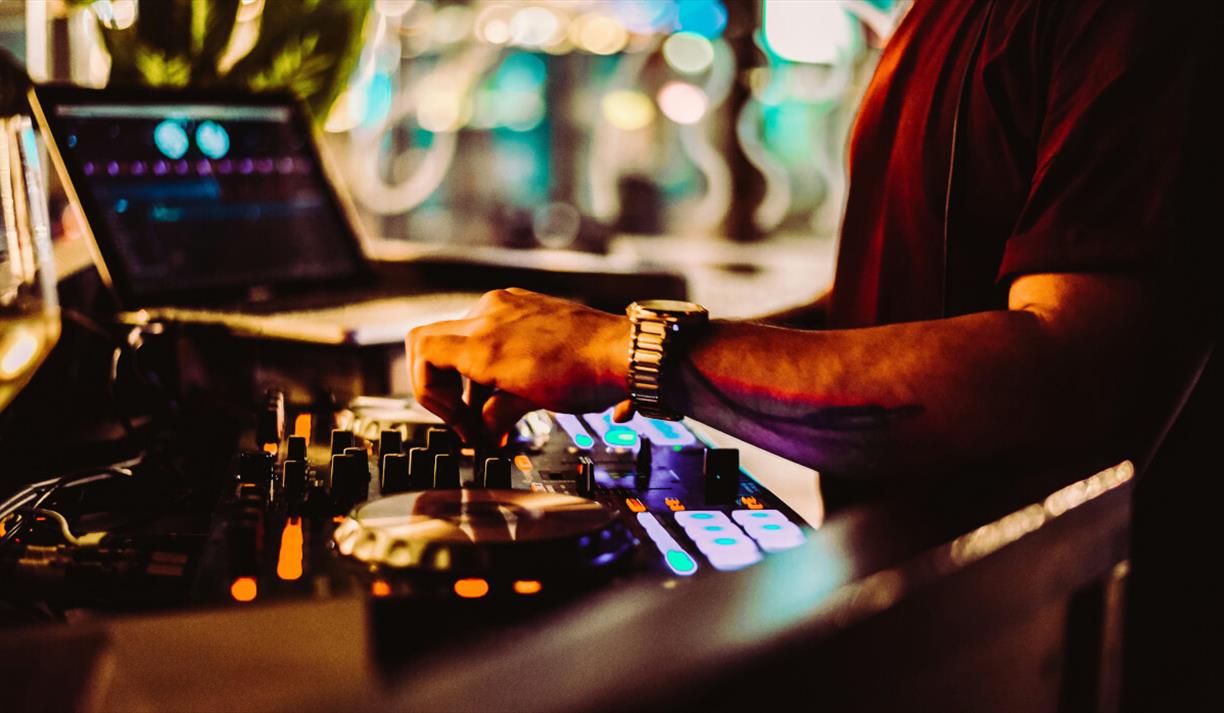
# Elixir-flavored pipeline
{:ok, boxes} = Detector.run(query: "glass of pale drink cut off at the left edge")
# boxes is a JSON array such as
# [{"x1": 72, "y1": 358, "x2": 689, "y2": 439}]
[{"x1": 0, "y1": 114, "x2": 60, "y2": 411}]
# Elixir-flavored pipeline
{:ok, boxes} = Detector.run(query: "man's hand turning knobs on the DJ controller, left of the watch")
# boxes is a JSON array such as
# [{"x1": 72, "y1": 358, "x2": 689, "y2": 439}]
[{"x1": 406, "y1": 287, "x2": 629, "y2": 443}]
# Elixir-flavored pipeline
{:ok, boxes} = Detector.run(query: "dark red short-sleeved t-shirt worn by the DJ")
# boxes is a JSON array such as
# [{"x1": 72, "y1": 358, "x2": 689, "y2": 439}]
[{"x1": 830, "y1": 0, "x2": 1219, "y2": 328}]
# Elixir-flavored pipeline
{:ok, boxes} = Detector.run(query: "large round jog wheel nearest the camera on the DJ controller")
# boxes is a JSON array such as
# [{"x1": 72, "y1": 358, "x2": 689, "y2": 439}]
[{"x1": 333, "y1": 488, "x2": 636, "y2": 598}]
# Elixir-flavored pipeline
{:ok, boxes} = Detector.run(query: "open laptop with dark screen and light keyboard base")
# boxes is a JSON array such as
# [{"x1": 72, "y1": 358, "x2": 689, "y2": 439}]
[{"x1": 29, "y1": 84, "x2": 479, "y2": 345}]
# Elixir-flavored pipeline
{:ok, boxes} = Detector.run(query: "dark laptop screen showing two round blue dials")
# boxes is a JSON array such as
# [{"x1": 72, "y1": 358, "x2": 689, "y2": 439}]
[{"x1": 31, "y1": 89, "x2": 362, "y2": 306}]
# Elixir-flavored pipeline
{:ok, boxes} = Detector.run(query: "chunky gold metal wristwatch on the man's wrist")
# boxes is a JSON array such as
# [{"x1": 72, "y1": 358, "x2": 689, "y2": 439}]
[{"x1": 625, "y1": 300, "x2": 710, "y2": 421}]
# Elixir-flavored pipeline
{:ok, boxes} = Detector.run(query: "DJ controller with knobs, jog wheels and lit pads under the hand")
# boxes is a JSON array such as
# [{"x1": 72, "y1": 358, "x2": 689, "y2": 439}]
[{"x1": 190, "y1": 393, "x2": 807, "y2": 613}]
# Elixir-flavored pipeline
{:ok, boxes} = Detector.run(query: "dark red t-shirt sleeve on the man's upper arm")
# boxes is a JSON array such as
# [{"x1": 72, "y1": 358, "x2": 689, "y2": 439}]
[{"x1": 998, "y1": 0, "x2": 1224, "y2": 281}]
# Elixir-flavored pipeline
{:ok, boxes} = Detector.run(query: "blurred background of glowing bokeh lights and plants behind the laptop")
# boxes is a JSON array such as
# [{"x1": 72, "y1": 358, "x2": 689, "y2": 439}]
[{"x1": 0, "y1": 0, "x2": 907, "y2": 312}]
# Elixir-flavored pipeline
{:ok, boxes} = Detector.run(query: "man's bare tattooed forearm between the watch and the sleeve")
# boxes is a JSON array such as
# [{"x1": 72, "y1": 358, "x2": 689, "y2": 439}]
[{"x1": 666, "y1": 309, "x2": 1132, "y2": 475}]
